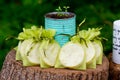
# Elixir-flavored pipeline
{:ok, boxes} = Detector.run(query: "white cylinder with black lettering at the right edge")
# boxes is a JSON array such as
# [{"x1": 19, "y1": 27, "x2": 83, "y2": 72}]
[{"x1": 112, "y1": 20, "x2": 120, "y2": 64}]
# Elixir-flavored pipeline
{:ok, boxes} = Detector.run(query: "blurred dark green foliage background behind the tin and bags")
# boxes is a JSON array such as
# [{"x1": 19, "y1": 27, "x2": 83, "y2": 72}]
[{"x1": 0, "y1": 0, "x2": 120, "y2": 69}]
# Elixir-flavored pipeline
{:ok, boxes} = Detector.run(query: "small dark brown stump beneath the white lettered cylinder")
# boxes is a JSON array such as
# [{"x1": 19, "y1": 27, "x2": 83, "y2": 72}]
[{"x1": 109, "y1": 53, "x2": 120, "y2": 80}]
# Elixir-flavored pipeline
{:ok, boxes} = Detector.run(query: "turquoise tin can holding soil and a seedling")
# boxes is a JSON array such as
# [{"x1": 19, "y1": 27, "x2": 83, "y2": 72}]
[{"x1": 45, "y1": 12, "x2": 76, "y2": 46}]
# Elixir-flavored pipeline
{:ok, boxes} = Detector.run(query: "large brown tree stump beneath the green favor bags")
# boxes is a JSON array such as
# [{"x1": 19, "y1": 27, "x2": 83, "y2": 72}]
[{"x1": 0, "y1": 50, "x2": 109, "y2": 80}]
